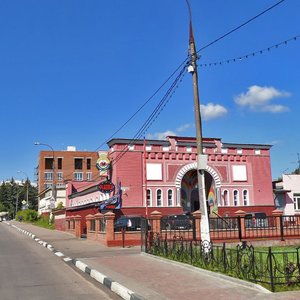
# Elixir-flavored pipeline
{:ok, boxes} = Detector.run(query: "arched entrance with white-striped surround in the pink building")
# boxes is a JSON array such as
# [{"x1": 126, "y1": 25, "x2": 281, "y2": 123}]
[{"x1": 176, "y1": 163, "x2": 221, "y2": 213}]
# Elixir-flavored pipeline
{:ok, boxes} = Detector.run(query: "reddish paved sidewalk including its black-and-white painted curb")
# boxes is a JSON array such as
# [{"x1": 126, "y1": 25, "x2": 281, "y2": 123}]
[{"x1": 7, "y1": 221, "x2": 300, "y2": 300}]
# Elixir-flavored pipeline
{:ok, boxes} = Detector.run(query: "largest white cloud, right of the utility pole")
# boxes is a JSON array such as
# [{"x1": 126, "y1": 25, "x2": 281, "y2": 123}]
[{"x1": 235, "y1": 85, "x2": 290, "y2": 113}]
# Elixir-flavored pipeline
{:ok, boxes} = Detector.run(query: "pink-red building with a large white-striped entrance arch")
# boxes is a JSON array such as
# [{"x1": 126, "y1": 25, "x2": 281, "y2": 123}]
[{"x1": 67, "y1": 136, "x2": 274, "y2": 225}]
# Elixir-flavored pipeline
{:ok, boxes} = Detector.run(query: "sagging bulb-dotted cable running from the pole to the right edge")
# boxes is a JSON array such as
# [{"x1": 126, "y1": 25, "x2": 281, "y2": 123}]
[{"x1": 199, "y1": 35, "x2": 300, "y2": 67}]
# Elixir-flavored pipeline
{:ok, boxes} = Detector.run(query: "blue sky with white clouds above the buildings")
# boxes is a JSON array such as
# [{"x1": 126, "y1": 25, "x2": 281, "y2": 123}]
[{"x1": 0, "y1": 0, "x2": 300, "y2": 180}]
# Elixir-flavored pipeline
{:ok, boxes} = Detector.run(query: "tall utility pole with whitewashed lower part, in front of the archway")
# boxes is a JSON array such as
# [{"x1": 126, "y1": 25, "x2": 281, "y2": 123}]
[{"x1": 186, "y1": 0, "x2": 210, "y2": 242}]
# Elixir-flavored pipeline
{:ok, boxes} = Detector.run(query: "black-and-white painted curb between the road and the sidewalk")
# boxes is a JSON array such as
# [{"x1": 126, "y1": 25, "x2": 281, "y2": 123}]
[{"x1": 4, "y1": 222, "x2": 145, "y2": 300}]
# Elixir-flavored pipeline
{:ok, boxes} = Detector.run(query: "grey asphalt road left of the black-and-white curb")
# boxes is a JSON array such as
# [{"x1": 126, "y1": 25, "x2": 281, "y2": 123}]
[{"x1": 0, "y1": 223, "x2": 120, "y2": 300}]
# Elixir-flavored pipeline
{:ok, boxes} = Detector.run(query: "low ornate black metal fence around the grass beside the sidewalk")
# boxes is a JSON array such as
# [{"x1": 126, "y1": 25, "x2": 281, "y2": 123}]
[{"x1": 142, "y1": 234, "x2": 300, "y2": 292}]
